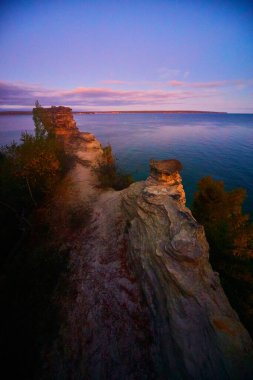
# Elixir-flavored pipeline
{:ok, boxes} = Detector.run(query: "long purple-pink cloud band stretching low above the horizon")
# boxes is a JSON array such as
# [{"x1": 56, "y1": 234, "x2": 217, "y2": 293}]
[{"x1": 0, "y1": 81, "x2": 215, "y2": 108}]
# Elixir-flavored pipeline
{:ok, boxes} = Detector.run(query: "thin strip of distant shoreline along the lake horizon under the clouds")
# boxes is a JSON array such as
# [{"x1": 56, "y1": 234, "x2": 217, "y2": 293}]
[{"x1": 0, "y1": 111, "x2": 228, "y2": 116}]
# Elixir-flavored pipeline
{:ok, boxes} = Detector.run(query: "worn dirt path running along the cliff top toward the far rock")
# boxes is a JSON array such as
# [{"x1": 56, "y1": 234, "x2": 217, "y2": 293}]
[{"x1": 45, "y1": 134, "x2": 157, "y2": 380}]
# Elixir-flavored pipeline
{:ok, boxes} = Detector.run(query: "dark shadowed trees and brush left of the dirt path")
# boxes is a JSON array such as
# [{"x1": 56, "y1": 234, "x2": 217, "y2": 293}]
[{"x1": 0, "y1": 104, "x2": 73, "y2": 379}]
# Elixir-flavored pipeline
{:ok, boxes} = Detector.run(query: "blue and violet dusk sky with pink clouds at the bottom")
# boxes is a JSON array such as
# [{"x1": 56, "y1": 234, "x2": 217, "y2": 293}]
[{"x1": 0, "y1": 0, "x2": 253, "y2": 113}]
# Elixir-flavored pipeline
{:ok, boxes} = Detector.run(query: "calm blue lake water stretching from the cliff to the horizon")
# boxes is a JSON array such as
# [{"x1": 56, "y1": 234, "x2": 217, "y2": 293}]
[{"x1": 0, "y1": 114, "x2": 253, "y2": 216}]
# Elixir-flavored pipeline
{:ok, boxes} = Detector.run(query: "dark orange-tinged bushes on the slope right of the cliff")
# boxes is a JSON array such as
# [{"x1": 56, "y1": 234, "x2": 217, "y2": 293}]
[{"x1": 192, "y1": 177, "x2": 253, "y2": 335}]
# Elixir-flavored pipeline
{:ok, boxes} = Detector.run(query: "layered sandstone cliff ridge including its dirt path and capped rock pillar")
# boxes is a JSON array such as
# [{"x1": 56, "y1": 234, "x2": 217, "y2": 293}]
[{"x1": 42, "y1": 107, "x2": 253, "y2": 380}]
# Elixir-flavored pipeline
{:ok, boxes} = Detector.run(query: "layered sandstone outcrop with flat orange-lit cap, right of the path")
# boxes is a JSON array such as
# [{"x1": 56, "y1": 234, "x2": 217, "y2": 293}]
[{"x1": 122, "y1": 160, "x2": 253, "y2": 380}]
